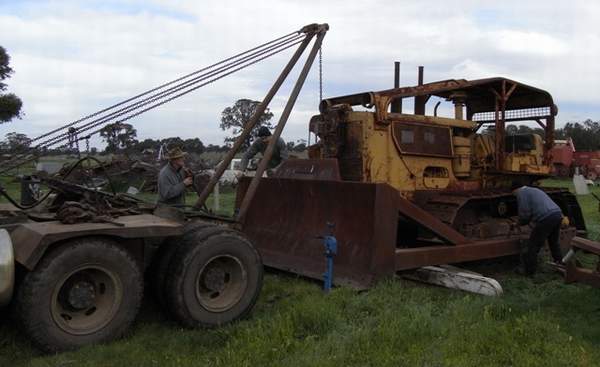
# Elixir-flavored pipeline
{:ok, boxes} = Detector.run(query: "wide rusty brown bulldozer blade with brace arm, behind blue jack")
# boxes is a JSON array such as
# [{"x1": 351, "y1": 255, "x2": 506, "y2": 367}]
[{"x1": 236, "y1": 178, "x2": 465, "y2": 288}]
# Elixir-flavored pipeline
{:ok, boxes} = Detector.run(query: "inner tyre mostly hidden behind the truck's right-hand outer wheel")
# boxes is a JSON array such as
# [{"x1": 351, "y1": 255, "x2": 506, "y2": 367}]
[{"x1": 150, "y1": 221, "x2": 215, "y2": 311}]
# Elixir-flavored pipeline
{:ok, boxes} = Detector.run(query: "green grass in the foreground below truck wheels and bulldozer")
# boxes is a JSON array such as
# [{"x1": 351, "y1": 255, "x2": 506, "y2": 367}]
[{"x1": 0, "y1": 181, "x2": 600, "y2": 367}]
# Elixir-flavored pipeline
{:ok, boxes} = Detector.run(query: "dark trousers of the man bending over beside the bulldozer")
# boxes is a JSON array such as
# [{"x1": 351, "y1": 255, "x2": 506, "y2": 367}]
[{"x1": 524, "y1": 212, "x2": 562, "y2": 275}]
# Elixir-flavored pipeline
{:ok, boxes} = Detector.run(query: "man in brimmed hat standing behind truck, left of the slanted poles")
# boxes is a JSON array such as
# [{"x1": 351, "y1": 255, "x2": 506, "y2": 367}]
[{"x1": 158, "y1": 148, "x2": 193, "y2": 205}]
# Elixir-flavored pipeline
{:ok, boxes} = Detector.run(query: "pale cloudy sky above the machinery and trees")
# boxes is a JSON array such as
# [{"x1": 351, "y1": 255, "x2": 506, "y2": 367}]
[{"x1": 0, "y1": 0, "x2": 600, "y2": 145}]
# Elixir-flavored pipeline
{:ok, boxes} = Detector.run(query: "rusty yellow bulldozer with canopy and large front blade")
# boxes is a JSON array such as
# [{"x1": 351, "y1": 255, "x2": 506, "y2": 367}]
[{"x1": 237, "y1": 73, "x2": 585, "y2": 288}]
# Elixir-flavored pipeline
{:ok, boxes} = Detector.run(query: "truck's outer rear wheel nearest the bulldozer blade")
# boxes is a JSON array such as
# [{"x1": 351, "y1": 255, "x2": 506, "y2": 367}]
[{"x1": 166, "y1": 227, "x2": 263, "y2": 327}]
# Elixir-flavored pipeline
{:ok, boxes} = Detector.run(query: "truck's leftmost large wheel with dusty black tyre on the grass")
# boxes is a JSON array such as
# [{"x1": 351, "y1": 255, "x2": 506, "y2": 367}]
[{"x1": 16, "y1": 238, "x2": 143, "y2": 352}]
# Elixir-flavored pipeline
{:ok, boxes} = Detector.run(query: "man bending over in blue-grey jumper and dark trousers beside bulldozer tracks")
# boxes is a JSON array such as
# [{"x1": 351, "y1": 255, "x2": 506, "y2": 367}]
[{"x1": 511, "y1": 181, "x2": 563, "y2": 276}]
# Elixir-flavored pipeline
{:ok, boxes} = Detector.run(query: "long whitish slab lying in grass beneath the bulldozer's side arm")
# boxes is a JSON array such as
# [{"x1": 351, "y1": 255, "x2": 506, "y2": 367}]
[{"x1": 403, "y1": 265, "x2": 502, "y2": 296}]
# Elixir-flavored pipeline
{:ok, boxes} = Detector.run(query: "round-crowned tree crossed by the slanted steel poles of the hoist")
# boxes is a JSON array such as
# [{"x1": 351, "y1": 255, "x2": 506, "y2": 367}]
[{"x1": 220, "y1": 99, "x2": 273, "y2": 148}]
